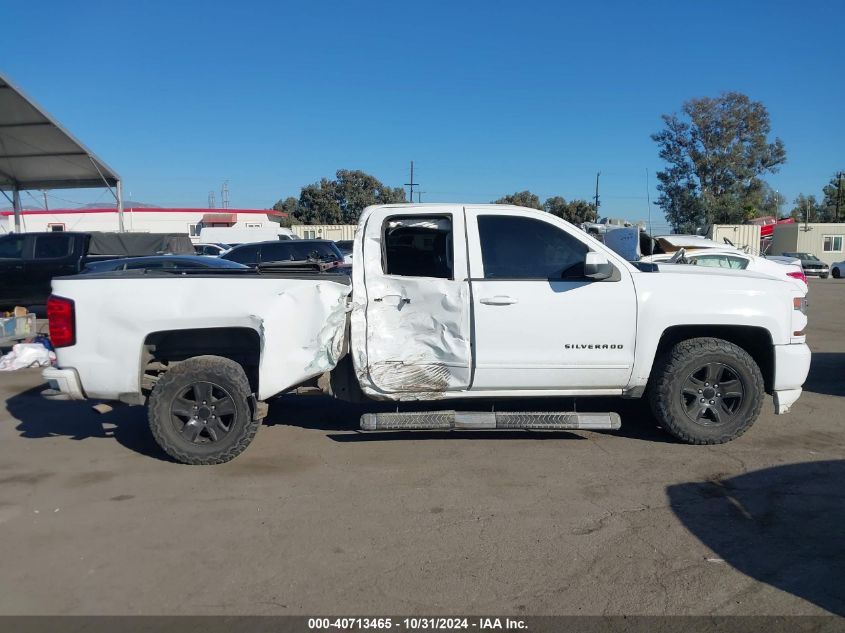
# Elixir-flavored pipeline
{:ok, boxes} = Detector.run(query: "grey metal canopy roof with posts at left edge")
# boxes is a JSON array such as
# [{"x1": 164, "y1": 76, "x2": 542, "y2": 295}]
[{"x1": 0, "y1": 74, "x2": 124, "y2": 232}]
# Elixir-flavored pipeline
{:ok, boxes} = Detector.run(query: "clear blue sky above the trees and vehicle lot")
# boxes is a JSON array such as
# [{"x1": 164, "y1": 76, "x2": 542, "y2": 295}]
[{"x1": 0, "y1": 0, "x2": 845, "y2": 227}]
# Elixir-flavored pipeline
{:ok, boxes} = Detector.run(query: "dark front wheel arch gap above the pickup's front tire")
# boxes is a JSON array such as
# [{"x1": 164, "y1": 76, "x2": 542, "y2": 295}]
[{"x1": 654, "y1": 325, "x2": 775, "y2": 394}]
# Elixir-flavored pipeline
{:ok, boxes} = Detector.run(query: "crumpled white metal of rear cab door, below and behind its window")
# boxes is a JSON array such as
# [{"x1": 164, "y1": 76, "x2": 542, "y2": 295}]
[{"x1": 351, "y1": 207, "x2": 470, "y2": 400}]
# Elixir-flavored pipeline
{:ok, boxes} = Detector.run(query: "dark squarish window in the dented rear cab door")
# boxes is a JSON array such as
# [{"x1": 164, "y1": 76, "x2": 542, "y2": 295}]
[{"x1": 383, "y1": 216, "x2": 454, "y2": 279}]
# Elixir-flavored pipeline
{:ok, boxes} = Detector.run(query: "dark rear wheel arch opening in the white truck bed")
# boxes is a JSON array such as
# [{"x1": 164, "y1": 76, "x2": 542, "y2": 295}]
[{"x1": 139, "y1": 327, "x2": 261, "y2": 395}]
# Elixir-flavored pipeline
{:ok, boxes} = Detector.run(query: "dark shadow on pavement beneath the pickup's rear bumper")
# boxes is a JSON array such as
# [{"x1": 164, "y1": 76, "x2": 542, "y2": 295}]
[{"x1": 6, "y1": 385, "x2": 172, "y2": 461}]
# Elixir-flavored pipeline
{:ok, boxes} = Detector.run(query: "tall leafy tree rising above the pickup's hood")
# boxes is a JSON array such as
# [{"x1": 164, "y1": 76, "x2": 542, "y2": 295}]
[{"x1": 651, "y1": 92, "x2": 786, "y2": 231}]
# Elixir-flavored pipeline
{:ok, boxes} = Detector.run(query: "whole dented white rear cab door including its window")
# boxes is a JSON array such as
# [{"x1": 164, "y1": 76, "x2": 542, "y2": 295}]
[{"x1": 356, "y1": 207, "x2": 471, "y2": 395}]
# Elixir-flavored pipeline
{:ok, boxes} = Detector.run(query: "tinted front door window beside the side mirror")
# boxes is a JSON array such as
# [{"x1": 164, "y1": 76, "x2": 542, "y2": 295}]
[{"x1": 478, "y1": 215, "x2": 589, "y2": 280}]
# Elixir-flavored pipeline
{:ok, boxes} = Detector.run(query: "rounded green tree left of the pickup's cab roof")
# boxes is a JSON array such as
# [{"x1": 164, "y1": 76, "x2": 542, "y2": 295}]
[{"x1": 293, "y1": 169, "x2": 405, "y2": 224}]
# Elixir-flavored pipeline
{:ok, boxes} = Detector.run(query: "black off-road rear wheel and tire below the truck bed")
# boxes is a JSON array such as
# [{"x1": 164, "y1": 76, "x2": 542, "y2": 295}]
[{"x1": 148, "y1": 356, "x2": 261, "y2": 465}]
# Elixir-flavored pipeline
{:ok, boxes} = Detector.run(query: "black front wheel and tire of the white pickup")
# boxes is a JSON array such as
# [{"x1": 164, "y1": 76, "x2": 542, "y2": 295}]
[{"x1": 649, "y1": 338, "x2": 765, "y2": 444}]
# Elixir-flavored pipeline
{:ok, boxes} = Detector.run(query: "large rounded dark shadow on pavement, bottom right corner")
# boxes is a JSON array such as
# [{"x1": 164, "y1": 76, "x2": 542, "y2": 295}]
[{"x1": 666, "y1": 460, "x2": 845, "y2": 616}]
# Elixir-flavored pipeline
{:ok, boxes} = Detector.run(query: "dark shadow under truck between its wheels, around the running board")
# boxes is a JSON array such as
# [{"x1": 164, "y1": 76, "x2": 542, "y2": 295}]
[{"x1": 264, "y1": 396, "x2": 674, "y2": 442}]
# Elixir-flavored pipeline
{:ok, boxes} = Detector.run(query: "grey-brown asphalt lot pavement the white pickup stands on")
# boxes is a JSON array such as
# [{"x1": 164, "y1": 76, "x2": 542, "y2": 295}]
[{"x1": 0, "y1": 280, "x2": 845, "y2": 615}]
